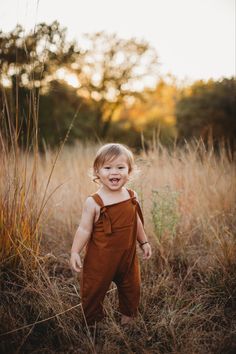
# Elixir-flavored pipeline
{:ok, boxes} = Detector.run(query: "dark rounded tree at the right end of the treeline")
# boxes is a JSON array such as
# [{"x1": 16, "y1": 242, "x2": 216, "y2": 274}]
[{"x1": 176, "y1": 78, "x2": 236, "y2": 156}]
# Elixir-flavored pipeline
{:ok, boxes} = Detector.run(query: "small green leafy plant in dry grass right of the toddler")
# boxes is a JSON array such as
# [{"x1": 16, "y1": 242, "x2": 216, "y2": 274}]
[{"x1": 151, "y1": 185, "x2": 180, "y2": 242}]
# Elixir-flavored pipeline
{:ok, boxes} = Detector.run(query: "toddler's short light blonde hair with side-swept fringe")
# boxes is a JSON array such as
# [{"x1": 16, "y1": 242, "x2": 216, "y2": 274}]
[{"x1": 93, "y1": 143, "x2": 134, "y2": 181}]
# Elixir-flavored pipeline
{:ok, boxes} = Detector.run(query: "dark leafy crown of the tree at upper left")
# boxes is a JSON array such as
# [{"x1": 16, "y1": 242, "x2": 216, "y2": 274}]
[{"x1": 0, "y1": 21, "x2": 78, "y2": 88}]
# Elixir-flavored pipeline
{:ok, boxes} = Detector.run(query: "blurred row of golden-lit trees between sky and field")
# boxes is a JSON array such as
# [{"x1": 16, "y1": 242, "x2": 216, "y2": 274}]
[{"x1": 0, "y1": 22, "x2": 236, "y2": 153}]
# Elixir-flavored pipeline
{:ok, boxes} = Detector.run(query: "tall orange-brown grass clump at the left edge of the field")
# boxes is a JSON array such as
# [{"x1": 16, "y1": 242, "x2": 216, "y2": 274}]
[{"x1": 0, "y1": 151, "x2": 40, "y2": 270}]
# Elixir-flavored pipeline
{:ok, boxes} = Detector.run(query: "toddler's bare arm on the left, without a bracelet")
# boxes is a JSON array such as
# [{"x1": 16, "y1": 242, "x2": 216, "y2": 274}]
[{"x1": 70, "y1": 197, "x2": 95, "y2": 272}]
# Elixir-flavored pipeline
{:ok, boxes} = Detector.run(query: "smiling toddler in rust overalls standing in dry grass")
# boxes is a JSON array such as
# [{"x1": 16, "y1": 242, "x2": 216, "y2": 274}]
[{"x1": 70, "y1": 143, "x2": 151, "y2": 325}]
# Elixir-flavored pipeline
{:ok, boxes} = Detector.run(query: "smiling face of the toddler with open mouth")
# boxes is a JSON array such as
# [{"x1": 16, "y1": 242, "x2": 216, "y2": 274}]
[{"x1": 97, "y1": 155, "x2": 129, "y2": 191}]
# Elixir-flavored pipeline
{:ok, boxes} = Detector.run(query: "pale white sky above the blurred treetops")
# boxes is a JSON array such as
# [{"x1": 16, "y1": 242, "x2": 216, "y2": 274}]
[{"x1": 0, "y1": 0, "x2": 236, "y2": 81}]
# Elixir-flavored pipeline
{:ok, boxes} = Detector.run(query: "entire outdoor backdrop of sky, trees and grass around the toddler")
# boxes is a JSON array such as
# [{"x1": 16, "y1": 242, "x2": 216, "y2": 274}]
[{"x1": 0, "y1": 0, "x2": 236, "y2": 354}]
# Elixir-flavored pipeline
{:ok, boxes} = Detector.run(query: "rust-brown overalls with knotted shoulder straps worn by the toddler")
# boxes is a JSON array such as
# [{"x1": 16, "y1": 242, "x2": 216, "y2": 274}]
[{"x1": 80, "y1": 189, "x2": 143, "y2": 324}]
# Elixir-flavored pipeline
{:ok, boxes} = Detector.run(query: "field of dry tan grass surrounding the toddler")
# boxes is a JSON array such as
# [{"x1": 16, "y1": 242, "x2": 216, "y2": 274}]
[{"x1": 0, "y1": 142, "x2": 236, "y2": 354}]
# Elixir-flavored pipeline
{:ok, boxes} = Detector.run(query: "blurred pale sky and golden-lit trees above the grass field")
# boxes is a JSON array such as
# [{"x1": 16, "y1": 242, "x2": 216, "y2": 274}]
[{"x1": 0, "y1": 0, "x2": 236, "y2": 151}]
